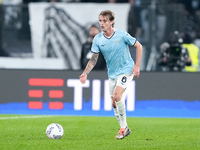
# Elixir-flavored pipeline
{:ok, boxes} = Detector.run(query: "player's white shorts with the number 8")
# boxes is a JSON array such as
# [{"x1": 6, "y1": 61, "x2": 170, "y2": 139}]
[{"x1": 109, "y1": 74, "x2": 133, "y2": 97}]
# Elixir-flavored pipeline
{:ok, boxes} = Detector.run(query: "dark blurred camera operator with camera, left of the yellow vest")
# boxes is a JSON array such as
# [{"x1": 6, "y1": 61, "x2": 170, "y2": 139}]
[{"x1": 158, "y1": 31, "x2": 191, "y2": 71}]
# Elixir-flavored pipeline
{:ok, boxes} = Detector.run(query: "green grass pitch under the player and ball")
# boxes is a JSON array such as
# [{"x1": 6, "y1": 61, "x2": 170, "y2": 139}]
[{"x1": 0, "y1": 115, "x2": 200, "y2": 150}]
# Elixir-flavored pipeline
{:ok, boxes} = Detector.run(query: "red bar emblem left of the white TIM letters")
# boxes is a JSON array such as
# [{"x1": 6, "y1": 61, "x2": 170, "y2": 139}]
[{"x1": 28, "y1": 78, "x2": 64, "y2": 109}]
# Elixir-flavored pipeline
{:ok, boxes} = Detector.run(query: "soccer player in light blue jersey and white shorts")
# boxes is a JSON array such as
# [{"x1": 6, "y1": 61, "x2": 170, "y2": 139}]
[{"x1": 79, "y1": 10, "x2": 142, "y2": 139}]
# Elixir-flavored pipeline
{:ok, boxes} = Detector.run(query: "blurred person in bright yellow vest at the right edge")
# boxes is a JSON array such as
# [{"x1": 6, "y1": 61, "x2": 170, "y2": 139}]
[{"x1": 183, "y1": 33, "x2": 199, "y2": 72}]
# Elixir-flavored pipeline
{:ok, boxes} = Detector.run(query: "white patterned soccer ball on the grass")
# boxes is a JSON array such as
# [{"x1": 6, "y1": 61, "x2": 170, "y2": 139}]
[{"x1": 46, "y1": 123, "x2": 64, "y2": 139}]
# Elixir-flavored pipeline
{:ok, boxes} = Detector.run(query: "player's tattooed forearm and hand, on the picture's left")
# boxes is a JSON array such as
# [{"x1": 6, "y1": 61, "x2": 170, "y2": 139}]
[{"x1": 79, "y1": 53, "x2": 99, "y2": 84}]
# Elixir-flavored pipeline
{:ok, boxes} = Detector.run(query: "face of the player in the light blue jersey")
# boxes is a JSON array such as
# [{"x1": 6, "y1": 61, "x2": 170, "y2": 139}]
[{"x1": 99, "y1": 15, "x2": 113, "y2": 32}]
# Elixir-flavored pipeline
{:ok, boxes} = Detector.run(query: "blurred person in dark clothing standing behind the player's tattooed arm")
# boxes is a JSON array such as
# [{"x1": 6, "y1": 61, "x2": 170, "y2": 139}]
[{"x1": 81, "y1": 24, "x2": 106, "y2": 70}]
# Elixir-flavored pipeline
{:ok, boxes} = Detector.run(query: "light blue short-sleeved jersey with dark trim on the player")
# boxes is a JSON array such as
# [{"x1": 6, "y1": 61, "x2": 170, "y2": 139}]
[{"x1": 91, "y1": 29, "x2": 136, "y2": 79}]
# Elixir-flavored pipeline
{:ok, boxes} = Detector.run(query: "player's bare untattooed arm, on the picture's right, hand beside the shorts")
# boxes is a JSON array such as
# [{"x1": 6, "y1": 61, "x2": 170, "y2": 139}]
[{"x1": 131, "y1": 41, "x2": 142, "y2": 77}]
